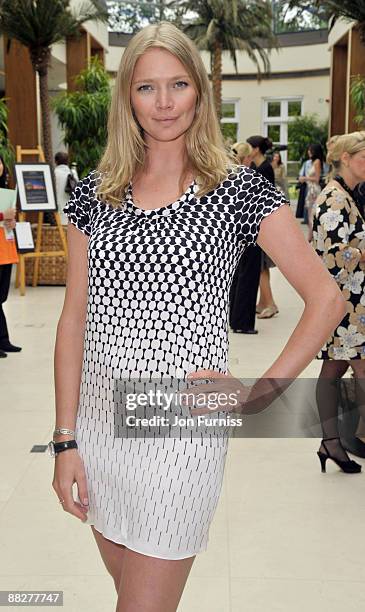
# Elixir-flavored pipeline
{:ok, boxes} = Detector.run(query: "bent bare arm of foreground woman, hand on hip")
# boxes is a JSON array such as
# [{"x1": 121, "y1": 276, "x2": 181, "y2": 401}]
[{"x1": 257, "y1": 206, "x2": 346, "y2": 379}]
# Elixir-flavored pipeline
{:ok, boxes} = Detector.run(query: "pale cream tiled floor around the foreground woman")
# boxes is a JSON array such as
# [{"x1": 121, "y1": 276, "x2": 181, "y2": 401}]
[{"x1": 0, "y1": 270, "x2": 365, "y2": 612}]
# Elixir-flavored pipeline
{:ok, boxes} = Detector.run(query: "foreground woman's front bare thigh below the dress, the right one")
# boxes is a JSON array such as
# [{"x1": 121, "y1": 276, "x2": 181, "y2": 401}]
[{"x1": 116, "y1": 548, "x2": 195, "y2": 612}]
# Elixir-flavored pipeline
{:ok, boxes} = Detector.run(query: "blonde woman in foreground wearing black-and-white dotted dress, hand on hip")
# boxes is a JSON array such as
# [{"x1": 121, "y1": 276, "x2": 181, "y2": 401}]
[{"x1": 50, "y1": 22, "x2": 344, "y2": 612}]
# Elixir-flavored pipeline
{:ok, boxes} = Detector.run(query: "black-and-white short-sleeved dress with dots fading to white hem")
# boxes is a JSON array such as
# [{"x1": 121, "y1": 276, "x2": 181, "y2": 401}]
[{"x1": 65, "y1": 166, "x2": 286, "y2": 559}]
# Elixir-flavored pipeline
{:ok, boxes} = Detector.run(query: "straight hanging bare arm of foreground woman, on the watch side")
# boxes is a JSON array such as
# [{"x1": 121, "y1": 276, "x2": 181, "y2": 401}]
[{"x1": 54, "y1": 223, "x2": 88, "y2": 441}]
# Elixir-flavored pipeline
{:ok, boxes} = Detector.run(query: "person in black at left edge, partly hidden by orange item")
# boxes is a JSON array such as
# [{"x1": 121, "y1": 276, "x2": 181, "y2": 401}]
[{"x1": 0, "y1": 155, "x2": 22, "y2": 359}]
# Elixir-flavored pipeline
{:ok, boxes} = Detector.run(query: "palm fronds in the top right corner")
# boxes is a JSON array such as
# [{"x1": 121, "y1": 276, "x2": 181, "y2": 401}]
[{"x1": 287, "y1": 0, "x2": 365, "y2": 44}]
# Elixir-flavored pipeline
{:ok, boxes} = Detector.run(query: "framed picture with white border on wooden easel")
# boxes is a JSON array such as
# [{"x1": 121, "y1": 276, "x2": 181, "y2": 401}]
[{"x1": 14, "y1": 163, "x2": 57, "y2": 212}]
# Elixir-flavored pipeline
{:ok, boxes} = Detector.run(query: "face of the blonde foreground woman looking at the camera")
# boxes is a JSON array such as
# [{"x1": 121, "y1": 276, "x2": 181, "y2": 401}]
[{"x1": 131, "y1": 47, "x2": 197, "y2": 142}]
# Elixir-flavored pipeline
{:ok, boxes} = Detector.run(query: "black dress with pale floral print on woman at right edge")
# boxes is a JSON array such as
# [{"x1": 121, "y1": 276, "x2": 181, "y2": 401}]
[{"x1": 313, "y1": 182, "x2": 365, "y2": 361}]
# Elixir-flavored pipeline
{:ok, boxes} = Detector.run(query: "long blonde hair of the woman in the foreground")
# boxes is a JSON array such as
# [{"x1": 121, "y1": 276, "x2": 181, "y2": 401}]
[{"x1": 97, "y1": 21, "x2": 234, "y2": 206}]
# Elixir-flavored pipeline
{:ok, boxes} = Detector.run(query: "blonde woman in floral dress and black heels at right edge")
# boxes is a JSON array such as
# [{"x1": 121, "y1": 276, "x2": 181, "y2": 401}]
[{"x1": 313, "y1": 132, "x2": 365, "y2": 473}]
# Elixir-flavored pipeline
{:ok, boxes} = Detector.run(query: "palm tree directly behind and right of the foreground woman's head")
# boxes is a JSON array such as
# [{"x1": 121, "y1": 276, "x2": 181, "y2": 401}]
[{"x1": 182, "y1": 0, "x2": 277, "y2": 117}]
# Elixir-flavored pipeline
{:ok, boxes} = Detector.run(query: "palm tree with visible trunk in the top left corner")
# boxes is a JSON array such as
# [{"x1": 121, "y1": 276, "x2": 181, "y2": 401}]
[{"x1": 0, "y1": 0, "x2": 108, "y2": 166}]
